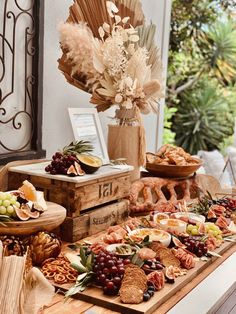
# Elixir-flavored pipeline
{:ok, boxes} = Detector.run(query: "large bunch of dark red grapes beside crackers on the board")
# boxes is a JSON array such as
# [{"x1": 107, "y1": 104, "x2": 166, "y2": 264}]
[{"x1": 93, "y1": 252, "x2": 130, "y2": 295}]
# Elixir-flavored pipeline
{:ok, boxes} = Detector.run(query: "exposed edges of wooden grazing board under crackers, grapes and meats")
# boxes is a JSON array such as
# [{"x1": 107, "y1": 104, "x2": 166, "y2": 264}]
[{"x1": 55, "y1": 238, "x2": 235, "y2": 314}]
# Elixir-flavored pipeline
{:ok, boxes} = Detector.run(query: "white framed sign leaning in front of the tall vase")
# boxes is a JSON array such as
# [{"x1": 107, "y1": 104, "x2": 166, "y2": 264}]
[{"x1": 68, "y1": 108, "x2": 109, "y2": 165}]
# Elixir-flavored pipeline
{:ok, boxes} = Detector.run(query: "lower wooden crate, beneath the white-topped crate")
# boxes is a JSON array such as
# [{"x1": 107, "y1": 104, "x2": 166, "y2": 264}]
[{"x1": 60, "y1": 200, "x2": 129, "y2": 242}]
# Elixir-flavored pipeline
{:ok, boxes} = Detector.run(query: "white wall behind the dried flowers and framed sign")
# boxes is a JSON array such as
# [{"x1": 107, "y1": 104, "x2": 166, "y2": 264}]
[{"x1": 43, "y1": 0, "x2": 171, "y2": 157}]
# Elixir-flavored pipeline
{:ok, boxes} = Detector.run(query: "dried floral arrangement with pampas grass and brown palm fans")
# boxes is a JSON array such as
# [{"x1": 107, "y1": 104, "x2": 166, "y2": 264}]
[{"x1": 58, "y1": 0, "x2": 163, "y2": 116}]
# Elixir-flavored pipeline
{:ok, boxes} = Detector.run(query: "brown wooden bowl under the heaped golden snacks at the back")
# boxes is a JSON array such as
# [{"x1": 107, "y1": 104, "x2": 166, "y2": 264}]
[{"x1": 146, "y1": 158, "x2": 202, "y2": 178}]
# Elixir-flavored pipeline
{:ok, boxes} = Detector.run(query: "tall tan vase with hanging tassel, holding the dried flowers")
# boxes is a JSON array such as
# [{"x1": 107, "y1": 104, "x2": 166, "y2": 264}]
[{"x1": 108, "y1": 110, "x2": 145, "y2": 181}]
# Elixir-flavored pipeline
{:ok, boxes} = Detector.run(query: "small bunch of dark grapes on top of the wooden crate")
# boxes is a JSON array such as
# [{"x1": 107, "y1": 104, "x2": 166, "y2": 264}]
[{"x1": 45, "y1": 152, "x2": 78, "y2": 174}]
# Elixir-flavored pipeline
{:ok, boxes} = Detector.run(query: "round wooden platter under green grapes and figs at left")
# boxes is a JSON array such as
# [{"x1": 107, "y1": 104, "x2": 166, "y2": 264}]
[{"x1": 0, "y1": 202, "x2": 66, "y2": 236}]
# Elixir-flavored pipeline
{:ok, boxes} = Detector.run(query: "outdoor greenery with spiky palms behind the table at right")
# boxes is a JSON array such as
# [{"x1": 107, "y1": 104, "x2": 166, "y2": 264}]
[{"x1": 164, "y1": 0, "x2": 236, "y2": 154}]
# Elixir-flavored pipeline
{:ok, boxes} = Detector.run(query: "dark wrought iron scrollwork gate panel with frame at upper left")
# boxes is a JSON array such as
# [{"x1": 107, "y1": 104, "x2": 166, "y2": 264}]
[{"x1": 0, "y1": 0, "x2": 45, "y2": 164}]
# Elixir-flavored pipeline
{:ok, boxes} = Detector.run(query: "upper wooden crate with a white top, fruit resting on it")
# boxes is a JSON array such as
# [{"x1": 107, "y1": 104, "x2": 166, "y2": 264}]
[{"x1": 8, "y1": 162, "x2": 132, "y2": 217}]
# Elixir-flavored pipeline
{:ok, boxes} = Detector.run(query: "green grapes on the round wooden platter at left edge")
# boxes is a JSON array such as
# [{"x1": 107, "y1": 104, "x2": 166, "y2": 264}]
[{"x1": 0, "y1": 192, "x2": 20, "y2": 218}]
